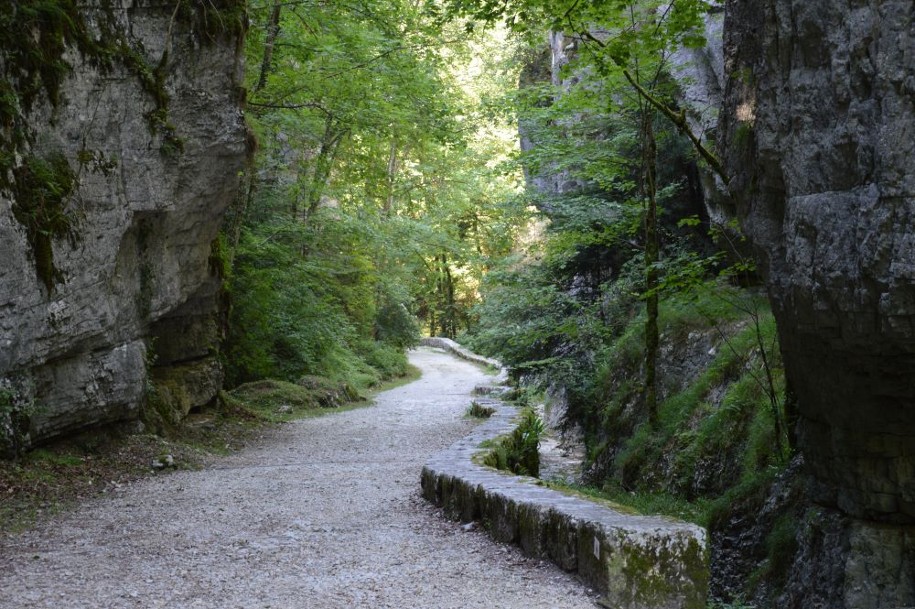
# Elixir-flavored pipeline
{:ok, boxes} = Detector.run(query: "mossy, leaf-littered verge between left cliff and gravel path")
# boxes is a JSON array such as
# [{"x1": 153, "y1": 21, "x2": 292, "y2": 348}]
[{"x1": 0, "y1": 366, "x2": 420, "y2": 533}]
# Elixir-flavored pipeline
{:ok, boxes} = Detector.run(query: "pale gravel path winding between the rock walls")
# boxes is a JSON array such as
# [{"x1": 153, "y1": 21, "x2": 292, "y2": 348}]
[{"x1": 0, "y1": 348, "x2": 596, "y2": 609}]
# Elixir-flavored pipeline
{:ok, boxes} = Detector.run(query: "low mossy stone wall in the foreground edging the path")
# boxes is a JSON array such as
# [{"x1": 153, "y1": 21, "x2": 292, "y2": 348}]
[{"x1": 421, "y1": 396, "x2": 709, "y2": 609}]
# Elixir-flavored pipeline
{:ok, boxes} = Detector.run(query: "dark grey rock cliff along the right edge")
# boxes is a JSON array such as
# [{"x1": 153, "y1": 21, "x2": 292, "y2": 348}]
[{"x1": 719, "y1": 0, "x2": 915, "y2": 607}]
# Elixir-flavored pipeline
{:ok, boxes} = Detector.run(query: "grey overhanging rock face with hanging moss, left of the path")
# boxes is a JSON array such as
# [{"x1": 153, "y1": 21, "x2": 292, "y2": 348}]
[{"x1": 0, "y1": 0, "x2": 246, "y2": 452}]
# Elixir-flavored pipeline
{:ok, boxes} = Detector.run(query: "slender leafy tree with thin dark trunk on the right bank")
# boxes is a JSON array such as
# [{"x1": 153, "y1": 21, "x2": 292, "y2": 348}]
[{"x1": 446, "y1": 0, "x2": 723, "y2": 423}]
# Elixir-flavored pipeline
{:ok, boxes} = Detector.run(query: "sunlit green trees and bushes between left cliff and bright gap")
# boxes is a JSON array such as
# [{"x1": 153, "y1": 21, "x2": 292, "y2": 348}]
[{"x1": 225, "y1": 0, "x2": 521, "y2": 387}]
